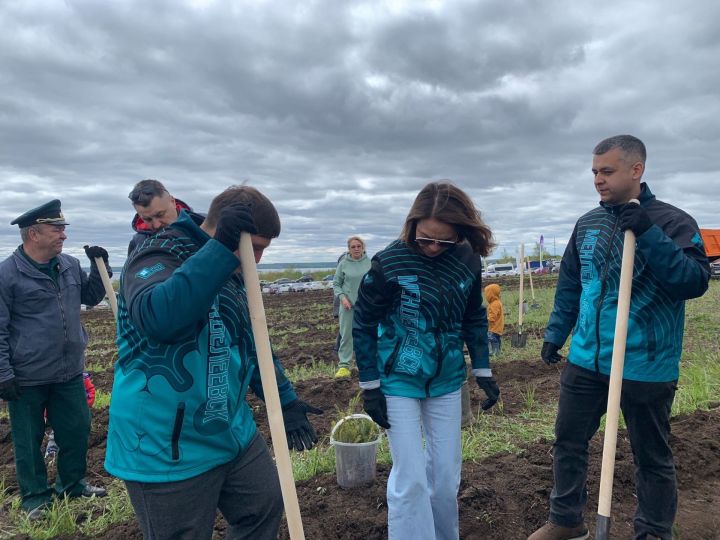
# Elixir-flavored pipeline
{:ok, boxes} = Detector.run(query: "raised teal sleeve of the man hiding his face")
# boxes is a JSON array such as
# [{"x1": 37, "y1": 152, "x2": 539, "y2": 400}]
[{"x1": 132, "y1": 240, "x2": 239, "y2": 343}]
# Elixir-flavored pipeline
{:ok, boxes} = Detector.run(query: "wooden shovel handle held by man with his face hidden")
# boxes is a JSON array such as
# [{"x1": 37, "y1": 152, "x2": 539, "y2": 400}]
[{"x1": 240, "y1": 232, "x2": 305, "y2": 540}]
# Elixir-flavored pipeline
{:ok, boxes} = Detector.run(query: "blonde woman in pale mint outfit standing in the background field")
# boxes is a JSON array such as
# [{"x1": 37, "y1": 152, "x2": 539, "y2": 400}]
[{"x1": 333, "y1": 236, "x2": 370, "y2": 378}]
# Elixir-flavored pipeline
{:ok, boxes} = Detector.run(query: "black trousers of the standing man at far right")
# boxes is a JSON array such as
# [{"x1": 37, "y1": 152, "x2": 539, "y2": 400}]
[{"x1": 550, "y1": 363, "x2": 677, "y2": 540}]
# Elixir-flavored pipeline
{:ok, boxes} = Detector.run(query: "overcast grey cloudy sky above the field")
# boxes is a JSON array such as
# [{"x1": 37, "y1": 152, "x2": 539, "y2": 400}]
[{"x1": 0, "y1": 0, "x2": 720, "y2": 266}]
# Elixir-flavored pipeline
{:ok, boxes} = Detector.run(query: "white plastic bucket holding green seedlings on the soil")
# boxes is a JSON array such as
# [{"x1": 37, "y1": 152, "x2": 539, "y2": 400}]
[{"x1": 330, "y1": 414, "x2": 382, "y2": 488}]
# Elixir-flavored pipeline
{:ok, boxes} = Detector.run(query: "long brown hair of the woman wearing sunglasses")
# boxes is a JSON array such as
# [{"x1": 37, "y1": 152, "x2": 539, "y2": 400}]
[{"x1": 400, "y1": 180, "x2": 495, "y2": 257}]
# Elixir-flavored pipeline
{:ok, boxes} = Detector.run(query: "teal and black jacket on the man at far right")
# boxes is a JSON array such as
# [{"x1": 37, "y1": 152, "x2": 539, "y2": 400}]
[{"x1": 545, "y1": 182, "x2": 710, "y2": 382}]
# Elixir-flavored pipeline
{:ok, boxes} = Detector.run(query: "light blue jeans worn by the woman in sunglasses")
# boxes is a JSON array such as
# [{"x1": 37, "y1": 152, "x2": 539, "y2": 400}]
[{"x1": 387, "y1": 390, "x2": 462, "y2": 540}]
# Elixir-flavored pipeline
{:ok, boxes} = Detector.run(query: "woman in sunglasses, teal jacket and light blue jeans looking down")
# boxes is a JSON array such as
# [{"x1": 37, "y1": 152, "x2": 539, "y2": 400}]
[{"x1": 353, "y1": 181, "x2": 500, "y2": 540}]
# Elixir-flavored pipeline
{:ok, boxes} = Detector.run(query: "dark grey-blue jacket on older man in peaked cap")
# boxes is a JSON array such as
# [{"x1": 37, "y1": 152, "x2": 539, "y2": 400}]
[{"x1": 0, "y1": 249, "x2": 105, "y2": 386}]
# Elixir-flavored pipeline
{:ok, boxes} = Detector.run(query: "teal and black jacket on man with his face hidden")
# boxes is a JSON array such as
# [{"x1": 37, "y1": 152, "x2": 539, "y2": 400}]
[{"x1": 105, "y1": 212, "x2": 296, "y2": 482}]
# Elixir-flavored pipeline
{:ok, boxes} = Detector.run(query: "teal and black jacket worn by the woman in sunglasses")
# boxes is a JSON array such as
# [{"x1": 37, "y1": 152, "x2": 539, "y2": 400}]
[{"x1": 353, "y1": 240, "x2": 492, "y2": 398}]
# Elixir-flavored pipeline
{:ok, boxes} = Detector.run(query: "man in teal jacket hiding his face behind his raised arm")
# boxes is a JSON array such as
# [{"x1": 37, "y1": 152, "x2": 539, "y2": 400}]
[{"x1": 105, "y1": 186, "x2": 322, "y2": 539}]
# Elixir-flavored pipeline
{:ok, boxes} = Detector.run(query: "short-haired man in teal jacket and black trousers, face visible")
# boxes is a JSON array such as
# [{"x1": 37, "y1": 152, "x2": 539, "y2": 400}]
[{"x1": 530, "y1": 135, "x2": 710, "y2": 540}]
